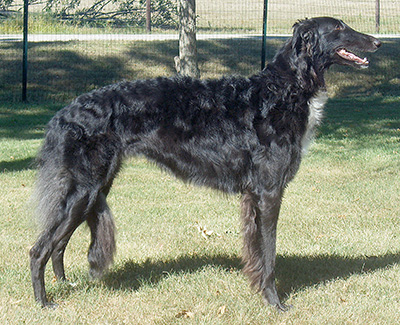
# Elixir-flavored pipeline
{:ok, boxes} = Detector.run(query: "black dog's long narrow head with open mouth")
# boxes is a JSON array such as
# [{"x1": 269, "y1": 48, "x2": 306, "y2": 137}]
[{"x1": 292, "y1": 17, "x2": 381, "y2": 68}]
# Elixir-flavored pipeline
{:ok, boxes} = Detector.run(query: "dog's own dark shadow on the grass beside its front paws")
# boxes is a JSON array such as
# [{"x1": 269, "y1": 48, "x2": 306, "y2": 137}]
[{"x1": 97, "y1": 253, "x2": 400, "y2": 304}]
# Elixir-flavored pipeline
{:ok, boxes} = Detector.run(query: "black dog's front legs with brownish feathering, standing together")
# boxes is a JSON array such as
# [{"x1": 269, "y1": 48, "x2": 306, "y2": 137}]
[{"x1": 242, "y1": 192, "x2": 288, "y2": 311}]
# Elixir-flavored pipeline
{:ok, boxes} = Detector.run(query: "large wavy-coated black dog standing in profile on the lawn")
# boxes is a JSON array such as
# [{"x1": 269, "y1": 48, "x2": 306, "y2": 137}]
[{"x1": 30, "y1": 17, "x2": 381, "y2": 310}]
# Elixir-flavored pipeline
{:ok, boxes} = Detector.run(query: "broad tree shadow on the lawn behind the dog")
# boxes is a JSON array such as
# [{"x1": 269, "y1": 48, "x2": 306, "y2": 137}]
[{"x1": 0, "y1": 38, "x2": 400, "y2": 168}]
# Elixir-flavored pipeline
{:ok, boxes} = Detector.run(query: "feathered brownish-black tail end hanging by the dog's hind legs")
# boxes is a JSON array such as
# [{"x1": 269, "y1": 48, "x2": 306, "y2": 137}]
[{"x1": 87, "y1": 193, "x2": 115, "y2": 278}]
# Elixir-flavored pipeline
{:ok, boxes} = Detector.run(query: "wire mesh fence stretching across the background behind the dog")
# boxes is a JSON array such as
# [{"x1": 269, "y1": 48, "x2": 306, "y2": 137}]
[{"x1": 0, "y1": 0, "x2": 400, "y2": 102}]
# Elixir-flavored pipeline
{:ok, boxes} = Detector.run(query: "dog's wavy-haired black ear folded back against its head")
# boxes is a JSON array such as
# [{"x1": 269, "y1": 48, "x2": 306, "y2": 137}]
[{"x1": 292, "y1": 19, "x2": 318, "y2": 56}]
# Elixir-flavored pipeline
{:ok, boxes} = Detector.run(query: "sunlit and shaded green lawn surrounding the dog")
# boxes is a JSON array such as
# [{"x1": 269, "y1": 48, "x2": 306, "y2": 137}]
[{"x1": 0, "y1": 40, "x2": 400, "y2": 324}]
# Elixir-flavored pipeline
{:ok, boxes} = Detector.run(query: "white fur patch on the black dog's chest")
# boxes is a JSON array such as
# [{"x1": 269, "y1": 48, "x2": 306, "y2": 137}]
[{"x1": 301, "y1": 91, "x2": 328, "y2": 156}]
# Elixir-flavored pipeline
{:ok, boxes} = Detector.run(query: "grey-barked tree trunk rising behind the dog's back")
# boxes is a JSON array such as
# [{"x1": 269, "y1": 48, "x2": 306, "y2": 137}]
[{"x1": 175, "y1": 0, "x2": 200, "y2": 78}]
